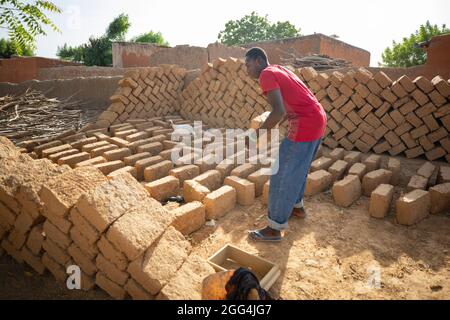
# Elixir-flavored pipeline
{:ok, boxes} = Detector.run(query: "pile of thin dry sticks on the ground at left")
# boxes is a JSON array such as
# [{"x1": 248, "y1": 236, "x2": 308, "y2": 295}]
[{"x1": 0, "y1": 90, "x2": 85, "y2": 143}]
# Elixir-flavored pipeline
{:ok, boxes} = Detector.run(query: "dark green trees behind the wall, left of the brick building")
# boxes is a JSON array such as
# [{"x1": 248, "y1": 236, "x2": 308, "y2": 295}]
[{"x1": 56, "y1": 14, "x2": 168, "y2": 66}]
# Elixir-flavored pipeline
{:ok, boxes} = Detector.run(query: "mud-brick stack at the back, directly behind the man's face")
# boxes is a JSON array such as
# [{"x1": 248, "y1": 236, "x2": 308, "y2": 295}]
[{"x1": 180, "y1": 58, "x2": 286, "y2": 135}]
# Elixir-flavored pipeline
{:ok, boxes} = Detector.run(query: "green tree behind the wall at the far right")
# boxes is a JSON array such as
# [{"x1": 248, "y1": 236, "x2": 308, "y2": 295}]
[{"x1": 380, "y1": 21, "x2": 450, "y2": 68}]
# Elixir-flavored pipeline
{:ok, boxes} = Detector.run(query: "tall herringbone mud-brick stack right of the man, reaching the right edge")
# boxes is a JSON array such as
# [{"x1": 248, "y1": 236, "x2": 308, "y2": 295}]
[{"x1": 298, "y1": 68, "x2": 450, "y2": 162}]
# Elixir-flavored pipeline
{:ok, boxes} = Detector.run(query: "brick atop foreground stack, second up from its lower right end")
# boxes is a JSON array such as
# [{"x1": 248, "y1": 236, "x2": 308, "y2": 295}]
[{"x1": 128, "y1": 227, "x2": 191, "y2": 295}]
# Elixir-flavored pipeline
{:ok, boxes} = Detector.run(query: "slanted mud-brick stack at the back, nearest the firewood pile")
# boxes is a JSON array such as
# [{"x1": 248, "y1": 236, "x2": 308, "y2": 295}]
[{"x1": 96, "y1": 65, "x2": 186, "y2": 127}]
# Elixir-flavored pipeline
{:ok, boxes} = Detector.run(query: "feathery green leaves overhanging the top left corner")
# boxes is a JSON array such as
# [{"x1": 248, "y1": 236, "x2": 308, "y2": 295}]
[{"x1": 0, "y1": 0, "x2": 62, "y2": 54}]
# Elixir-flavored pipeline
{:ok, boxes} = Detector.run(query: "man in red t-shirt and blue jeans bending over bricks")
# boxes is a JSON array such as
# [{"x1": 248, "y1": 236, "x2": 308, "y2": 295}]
[{"x1": 245, "y1": 48, "x2": 327, "y2": 242}]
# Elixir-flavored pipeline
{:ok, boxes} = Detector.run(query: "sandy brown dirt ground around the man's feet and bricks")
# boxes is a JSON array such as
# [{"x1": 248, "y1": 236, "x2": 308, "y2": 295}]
[{"x1": 0, "y1": 154, "x2": 450, "y2": 300}]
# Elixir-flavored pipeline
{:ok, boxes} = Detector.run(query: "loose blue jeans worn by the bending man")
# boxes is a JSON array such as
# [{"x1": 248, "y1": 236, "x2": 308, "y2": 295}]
[{"x1": 269, "y1": 138, "x2": 322, "y2": 231}]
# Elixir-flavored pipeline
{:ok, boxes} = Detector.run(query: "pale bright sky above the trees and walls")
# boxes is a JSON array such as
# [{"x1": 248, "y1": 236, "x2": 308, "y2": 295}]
[{"x1": 0, "y1": 0, "x2": 450, "y2": 66}]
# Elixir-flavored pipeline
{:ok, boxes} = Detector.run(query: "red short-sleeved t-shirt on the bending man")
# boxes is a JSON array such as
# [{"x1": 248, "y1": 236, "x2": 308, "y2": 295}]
[{"x1": 259, "y1": 65, "x2": 327, "y2": 142}]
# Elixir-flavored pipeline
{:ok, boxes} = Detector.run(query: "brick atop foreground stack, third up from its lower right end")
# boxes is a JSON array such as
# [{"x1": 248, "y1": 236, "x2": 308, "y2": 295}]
[{"x1": 106, "y1": 198, "x2": 173, "y2": 260}]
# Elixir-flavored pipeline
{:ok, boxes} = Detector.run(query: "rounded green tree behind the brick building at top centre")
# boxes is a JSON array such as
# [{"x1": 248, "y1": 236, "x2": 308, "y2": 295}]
[{"x1": 218, "y1": 12, "x2": 301, "y2": 45}]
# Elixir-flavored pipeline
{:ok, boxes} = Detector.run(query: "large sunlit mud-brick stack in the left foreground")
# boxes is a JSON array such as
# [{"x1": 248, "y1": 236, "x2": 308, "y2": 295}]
[{"x1": 0, "y1": 138, "x2": 214, "y2": 299}]
